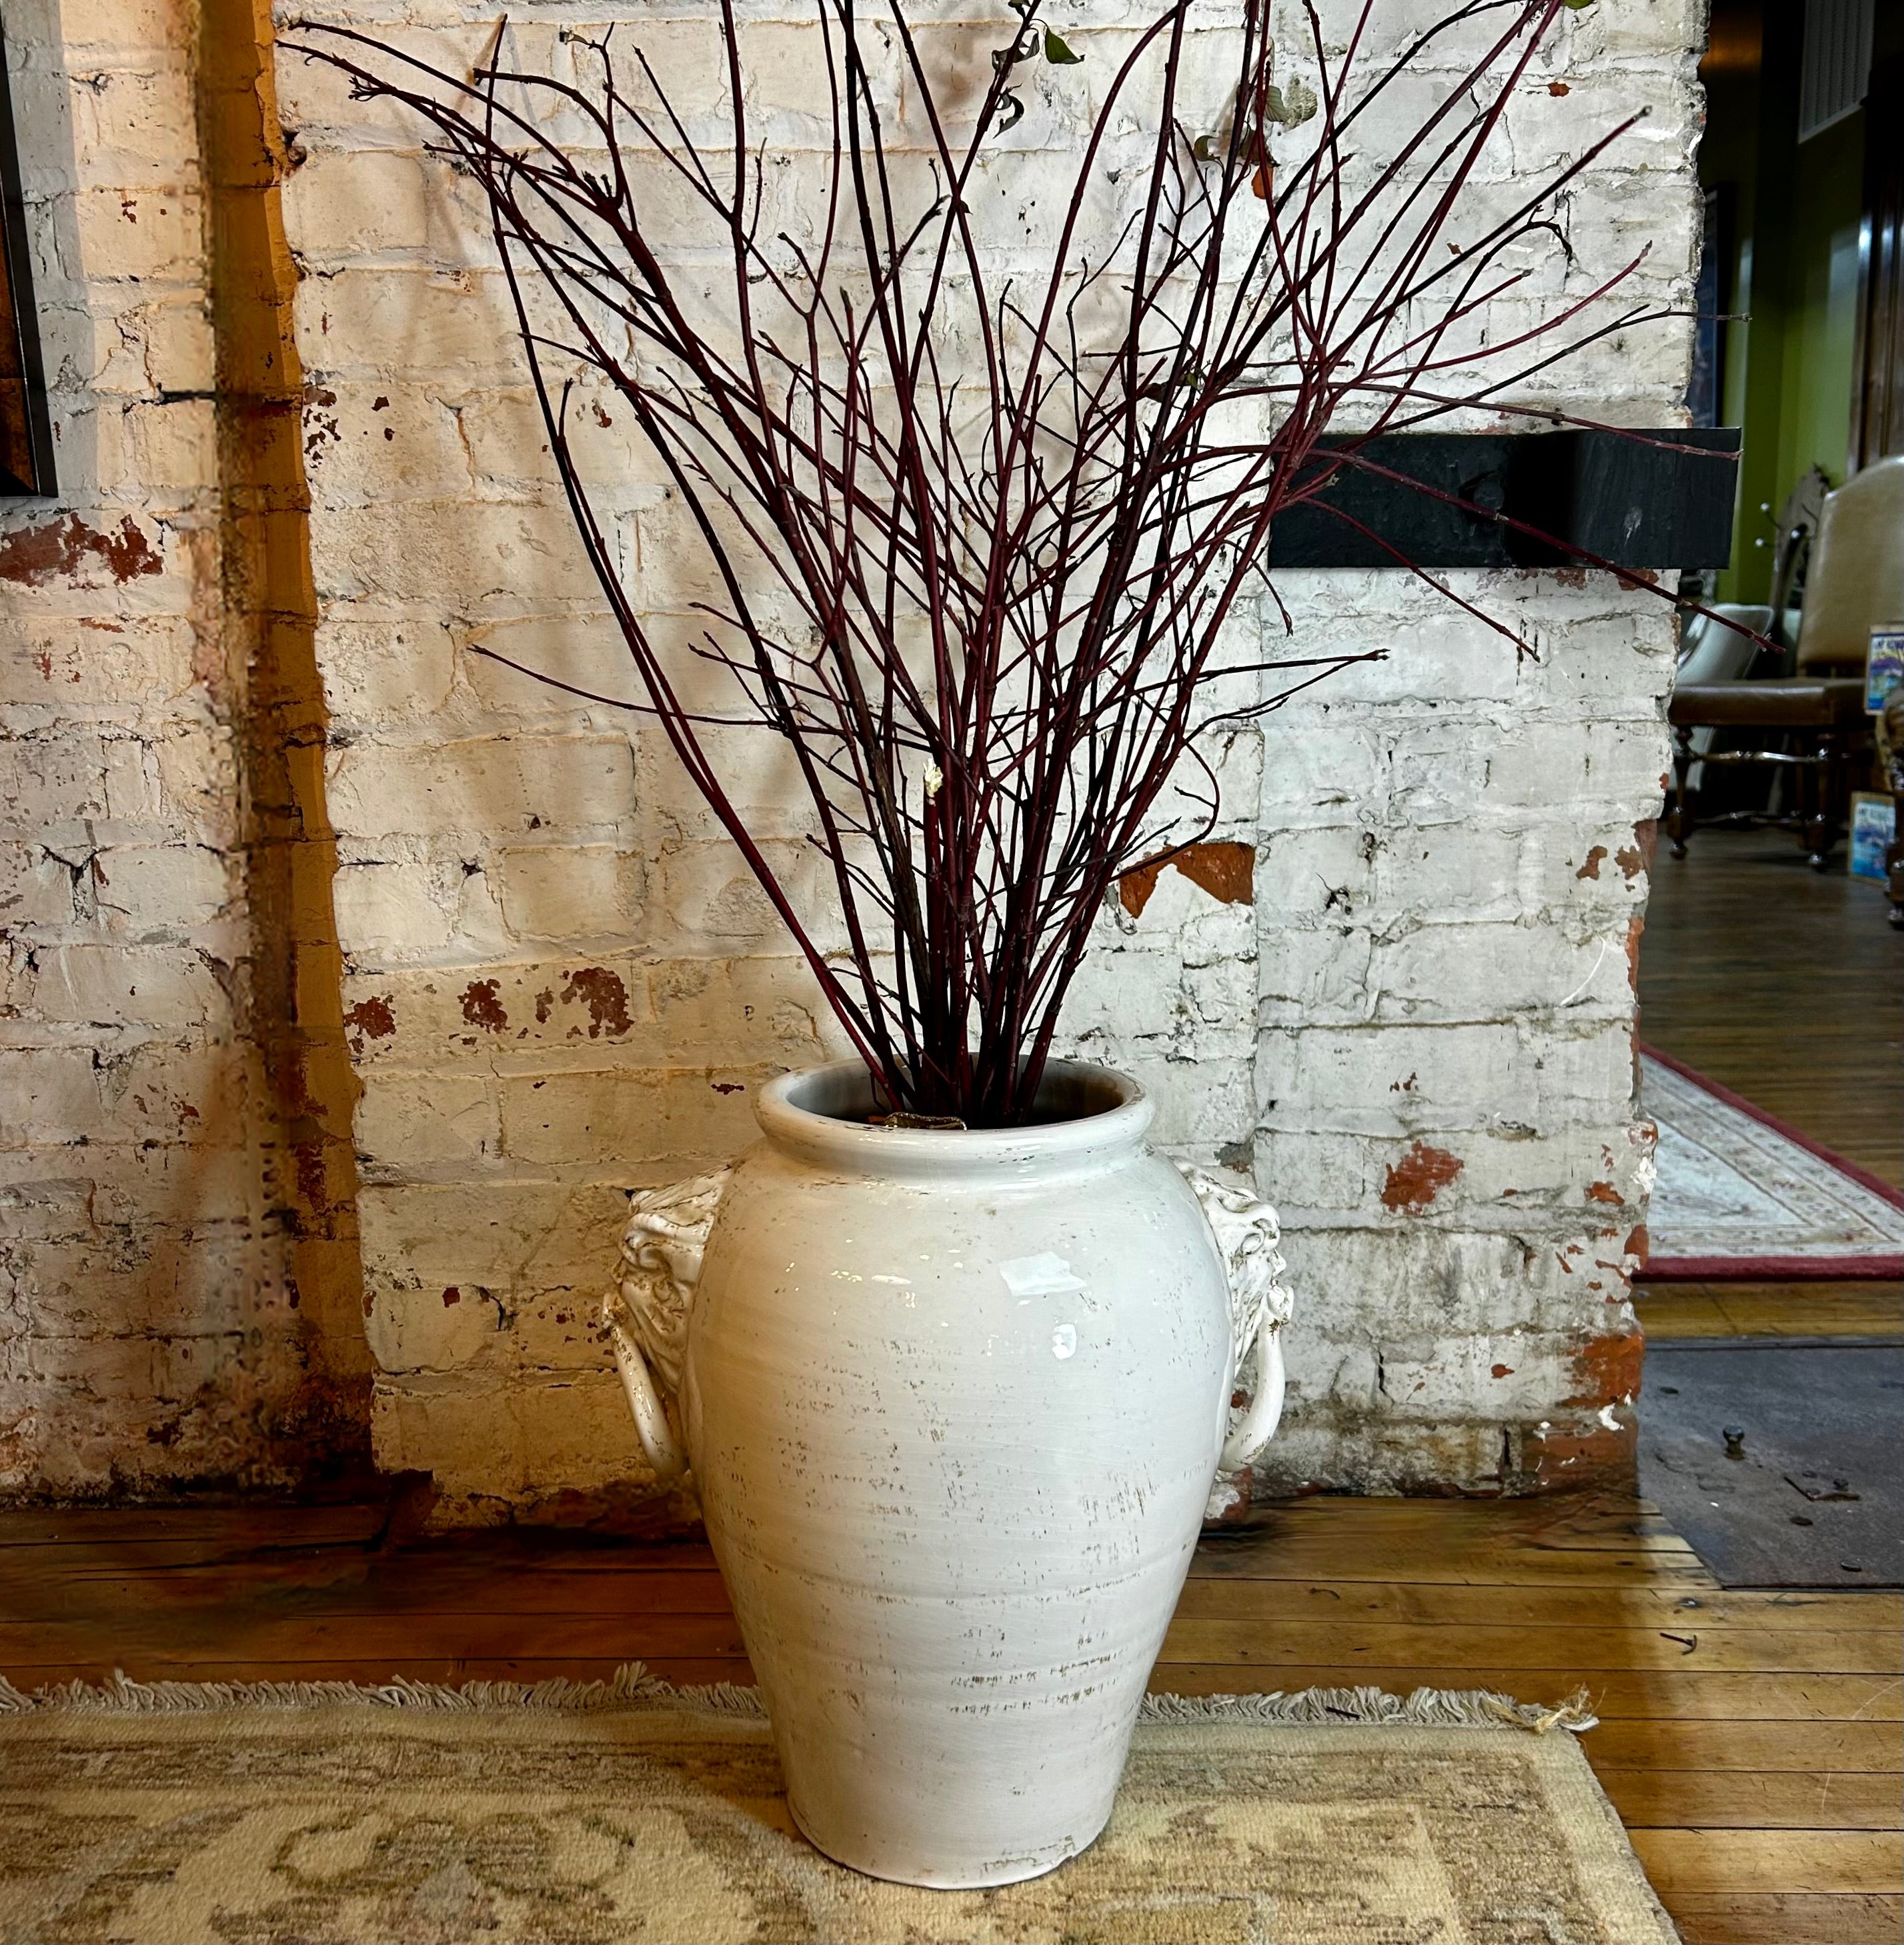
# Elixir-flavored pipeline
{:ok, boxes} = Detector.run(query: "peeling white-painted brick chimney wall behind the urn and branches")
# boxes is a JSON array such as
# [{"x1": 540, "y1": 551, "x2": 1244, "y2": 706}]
[{"x1": 278, "y1": 0, "x2": 1700, "y2": 1517}]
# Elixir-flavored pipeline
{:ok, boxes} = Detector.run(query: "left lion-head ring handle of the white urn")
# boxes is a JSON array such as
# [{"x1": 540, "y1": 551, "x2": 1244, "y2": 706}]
[{"x1": 601, "y1": 1169, "x2": 732, "y2": 1480}]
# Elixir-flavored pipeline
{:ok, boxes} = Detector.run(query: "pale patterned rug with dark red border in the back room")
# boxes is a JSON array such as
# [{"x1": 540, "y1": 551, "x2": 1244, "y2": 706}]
[{"x1": 1639, "y1": 1048, "x2": 1904, "y2": 1284}]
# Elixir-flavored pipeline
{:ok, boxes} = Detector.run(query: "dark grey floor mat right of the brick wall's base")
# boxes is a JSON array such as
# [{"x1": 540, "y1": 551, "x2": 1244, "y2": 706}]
[{"x1": 1639, "y1": 1338, "x2": 1904, "y2": 1587}]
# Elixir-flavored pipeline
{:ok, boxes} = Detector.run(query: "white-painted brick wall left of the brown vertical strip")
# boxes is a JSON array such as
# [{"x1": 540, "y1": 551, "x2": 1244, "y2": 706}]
[{"x1": 0, "y1": 0, "x2": 325, "y2": 1498}]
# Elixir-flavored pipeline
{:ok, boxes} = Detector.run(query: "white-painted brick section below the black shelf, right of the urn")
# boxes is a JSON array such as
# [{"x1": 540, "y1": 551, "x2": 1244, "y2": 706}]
[{"x1": 1254, "y1": 563, "x2": 1673, "y2": 1490}]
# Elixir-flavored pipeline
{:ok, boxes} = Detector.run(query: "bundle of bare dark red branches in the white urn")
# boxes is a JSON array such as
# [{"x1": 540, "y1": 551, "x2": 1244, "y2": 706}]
[{"x1": 291, "y1": 0, "x2": 1671, "y2": 1126}]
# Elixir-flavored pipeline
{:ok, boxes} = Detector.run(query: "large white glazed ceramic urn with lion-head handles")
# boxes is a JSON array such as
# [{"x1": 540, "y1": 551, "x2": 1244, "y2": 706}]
[{"x1": 607, "y1": 1062, "x2": 1288, "y2": 1886}]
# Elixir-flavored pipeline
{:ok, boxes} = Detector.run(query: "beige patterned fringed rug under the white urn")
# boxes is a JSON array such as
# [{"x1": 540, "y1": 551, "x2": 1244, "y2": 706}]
[{"x1": 0, "y1": 1669, "x2": 1675, "y2": 1945}]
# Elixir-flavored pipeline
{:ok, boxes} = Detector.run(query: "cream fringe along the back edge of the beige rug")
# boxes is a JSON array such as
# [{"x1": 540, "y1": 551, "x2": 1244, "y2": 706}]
[{"x1": 0, "y1": 1661, "x2": 1599, "y2": 1735}]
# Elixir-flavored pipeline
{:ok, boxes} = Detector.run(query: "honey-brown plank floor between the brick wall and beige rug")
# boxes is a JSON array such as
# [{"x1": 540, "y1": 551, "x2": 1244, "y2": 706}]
[{"x1": 0, "y1": 1498, "x2": 1904, "y2": 1945}]
